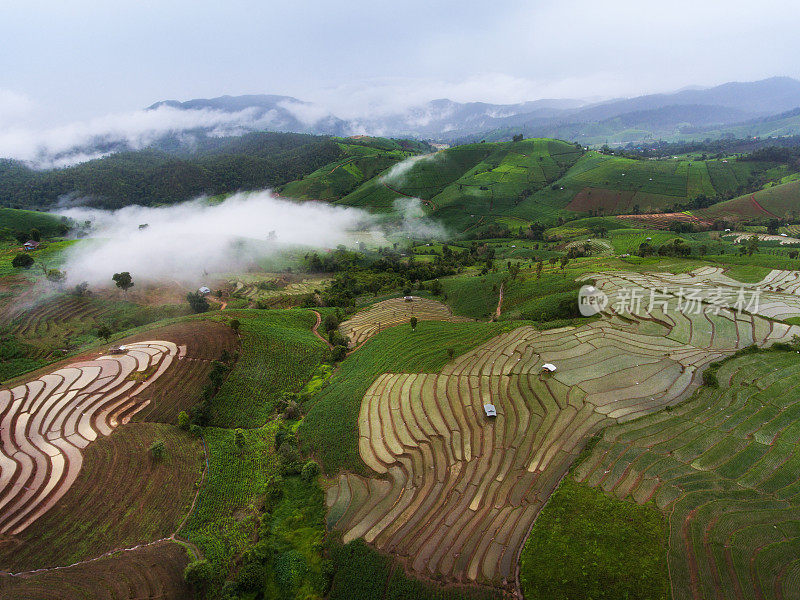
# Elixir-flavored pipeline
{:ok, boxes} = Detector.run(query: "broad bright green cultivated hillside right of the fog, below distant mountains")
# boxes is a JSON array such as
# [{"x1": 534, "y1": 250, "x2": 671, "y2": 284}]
[{"x1": 322, "y1": 139, "x2": 788, "y2": 232}]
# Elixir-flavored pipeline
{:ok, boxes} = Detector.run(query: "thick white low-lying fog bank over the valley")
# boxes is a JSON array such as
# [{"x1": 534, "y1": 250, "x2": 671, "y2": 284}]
[{"x1": 59, "y1": 191, "x2": 445, "y2": 286}]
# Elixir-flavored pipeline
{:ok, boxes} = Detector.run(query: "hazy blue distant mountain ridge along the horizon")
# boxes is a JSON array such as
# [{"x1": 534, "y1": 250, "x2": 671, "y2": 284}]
[{"x1": 149, "y1": 77, "x2": 800, "y2": 144}]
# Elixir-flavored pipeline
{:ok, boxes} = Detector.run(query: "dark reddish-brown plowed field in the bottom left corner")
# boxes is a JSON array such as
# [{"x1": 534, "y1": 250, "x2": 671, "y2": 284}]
[{"x1": 0, "y1": 541, "x2": 194, "y2": 600}]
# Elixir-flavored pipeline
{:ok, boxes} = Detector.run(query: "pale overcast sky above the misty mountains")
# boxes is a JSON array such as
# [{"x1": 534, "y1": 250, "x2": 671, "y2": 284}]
[{"x1": 0, "y1": 0, "x2": 800, "y2": 127}]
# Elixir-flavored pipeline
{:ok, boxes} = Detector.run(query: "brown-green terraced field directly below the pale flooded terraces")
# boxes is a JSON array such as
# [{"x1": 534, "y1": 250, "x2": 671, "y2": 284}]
[{"x1": 0, "y1": 423, "x2": 200, "y2": 573}]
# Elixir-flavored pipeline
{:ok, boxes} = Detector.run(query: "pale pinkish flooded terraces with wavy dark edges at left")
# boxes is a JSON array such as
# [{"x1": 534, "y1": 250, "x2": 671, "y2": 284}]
[{"x1": 0, "y1": 341, "x2": 179, "y2": 536}]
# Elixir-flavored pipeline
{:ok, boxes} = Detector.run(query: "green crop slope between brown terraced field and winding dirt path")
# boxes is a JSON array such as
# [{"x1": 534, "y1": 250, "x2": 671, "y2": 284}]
[{"x1": 211, "y1": 309, "x2": 328, "y2": 427}]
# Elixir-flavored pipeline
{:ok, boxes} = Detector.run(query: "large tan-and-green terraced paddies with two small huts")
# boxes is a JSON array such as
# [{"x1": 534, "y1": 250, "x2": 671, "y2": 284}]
[{"x1": 327, "y1": 269, "x2": 800, "y2": 587}]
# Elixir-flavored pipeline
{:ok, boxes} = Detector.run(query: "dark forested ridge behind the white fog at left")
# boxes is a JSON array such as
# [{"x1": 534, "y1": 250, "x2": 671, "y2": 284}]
[{"x1": 0, "y1": 133, "x2": 342, "y2": 208}]
